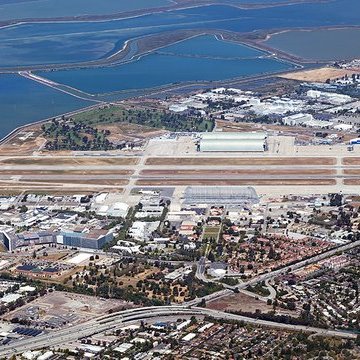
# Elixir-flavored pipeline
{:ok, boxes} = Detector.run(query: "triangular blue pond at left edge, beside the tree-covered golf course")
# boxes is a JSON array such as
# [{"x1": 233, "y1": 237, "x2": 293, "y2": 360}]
[{"x1": 0, "y1": 74, "x2": 93, "y2": 138}]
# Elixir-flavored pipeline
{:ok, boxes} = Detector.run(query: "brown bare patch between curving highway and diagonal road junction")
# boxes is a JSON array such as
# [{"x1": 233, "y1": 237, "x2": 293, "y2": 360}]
[{"x1": 206, "y1": 293, "x2": 294, "y2": 314}]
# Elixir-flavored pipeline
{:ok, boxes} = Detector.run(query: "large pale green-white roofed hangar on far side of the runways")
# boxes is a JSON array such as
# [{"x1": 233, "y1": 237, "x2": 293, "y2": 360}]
[{"x1": 198, "y1": 132, "x2": 267, "y2": 152}]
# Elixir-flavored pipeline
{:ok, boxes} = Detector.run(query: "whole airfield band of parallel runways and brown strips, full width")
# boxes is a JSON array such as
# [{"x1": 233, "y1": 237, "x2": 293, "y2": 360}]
[{"x1": 0, "y1": 154, "x2": 360, "y2": 192}]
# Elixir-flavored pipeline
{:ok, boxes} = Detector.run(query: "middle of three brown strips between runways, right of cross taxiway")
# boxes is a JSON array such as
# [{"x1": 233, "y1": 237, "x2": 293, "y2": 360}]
[{"x1": 141, "y1": 169, "x2": 334, "y2": 177}]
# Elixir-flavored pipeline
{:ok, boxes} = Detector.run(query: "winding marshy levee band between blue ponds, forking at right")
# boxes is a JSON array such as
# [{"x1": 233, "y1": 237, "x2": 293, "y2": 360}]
[{"x1": 0, "y1": 21, "x2": 360, "y2": 74}]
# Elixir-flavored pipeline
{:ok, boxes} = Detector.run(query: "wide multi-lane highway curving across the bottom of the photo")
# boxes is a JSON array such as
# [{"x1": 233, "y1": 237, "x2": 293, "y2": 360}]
[{"x1": 0, "y1": 306, "x2": 356, "y2": 357}]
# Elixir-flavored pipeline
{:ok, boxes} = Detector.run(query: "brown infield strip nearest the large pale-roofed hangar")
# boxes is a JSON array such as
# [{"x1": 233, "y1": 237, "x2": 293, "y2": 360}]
[{"x1": 146, "y1": 157, "x2": 336, "y2": 166}]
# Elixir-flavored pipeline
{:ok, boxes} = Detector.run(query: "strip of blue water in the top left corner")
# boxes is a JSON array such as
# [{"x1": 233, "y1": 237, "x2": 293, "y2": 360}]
[{"x1": 0, "y1": 0, "x2": 171, "y2": 20}]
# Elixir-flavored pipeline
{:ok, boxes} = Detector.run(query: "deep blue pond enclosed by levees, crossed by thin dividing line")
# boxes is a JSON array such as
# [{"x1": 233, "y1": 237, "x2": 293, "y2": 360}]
[{"x1": 38, "y1": 36, "x2": 291, "y2": 94}]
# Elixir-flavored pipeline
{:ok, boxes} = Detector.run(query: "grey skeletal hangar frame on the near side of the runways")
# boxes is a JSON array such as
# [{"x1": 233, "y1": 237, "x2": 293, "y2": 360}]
[{"x1": 184, "y1": 186, "x2": 259, "y2": 205}]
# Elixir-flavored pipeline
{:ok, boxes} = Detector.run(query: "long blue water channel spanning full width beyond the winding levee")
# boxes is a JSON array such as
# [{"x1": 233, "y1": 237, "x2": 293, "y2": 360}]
[{"x1": 0, "y1": 0, "x2": 360, "y2": 67}]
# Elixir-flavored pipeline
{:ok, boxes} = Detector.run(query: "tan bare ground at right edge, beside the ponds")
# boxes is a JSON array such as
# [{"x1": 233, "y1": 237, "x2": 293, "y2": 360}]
[{"x1": 280, "y1": 67, "x2": 359, "y2": 82}]
